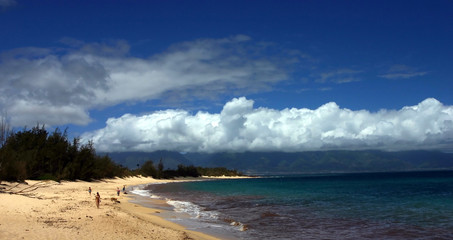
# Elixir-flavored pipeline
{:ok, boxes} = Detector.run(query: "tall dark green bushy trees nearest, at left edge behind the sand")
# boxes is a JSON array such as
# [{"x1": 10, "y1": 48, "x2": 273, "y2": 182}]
[{"x1": 0, "y1": 125, "x2": 128, "y2": 181}]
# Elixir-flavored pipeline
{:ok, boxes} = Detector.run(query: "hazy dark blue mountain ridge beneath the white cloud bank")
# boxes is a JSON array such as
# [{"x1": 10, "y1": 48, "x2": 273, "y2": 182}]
[{"x1": 106, "y1": 150, "x2": 453, "y2": 174}]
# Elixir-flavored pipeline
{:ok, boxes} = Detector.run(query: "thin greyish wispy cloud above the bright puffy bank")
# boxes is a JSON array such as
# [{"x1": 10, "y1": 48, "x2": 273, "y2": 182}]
[{"x1": 0, "y1": 35, "x2": 287, "y2": 127}]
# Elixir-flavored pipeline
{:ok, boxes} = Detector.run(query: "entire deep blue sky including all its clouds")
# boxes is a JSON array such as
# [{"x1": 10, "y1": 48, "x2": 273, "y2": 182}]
[{"x1": 0, "y1": 0, "x2": 453, "y2": 152}]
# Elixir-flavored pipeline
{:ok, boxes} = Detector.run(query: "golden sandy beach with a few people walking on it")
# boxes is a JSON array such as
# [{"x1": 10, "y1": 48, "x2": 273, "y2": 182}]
[{"x1": 0, "y1": 177, "x2": 217, "y2": 240}]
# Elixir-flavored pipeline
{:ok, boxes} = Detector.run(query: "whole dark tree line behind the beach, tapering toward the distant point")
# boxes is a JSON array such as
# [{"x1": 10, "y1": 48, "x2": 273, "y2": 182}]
[{"x1": 0, "y1": 124, "x2": 240, "y2": 181}]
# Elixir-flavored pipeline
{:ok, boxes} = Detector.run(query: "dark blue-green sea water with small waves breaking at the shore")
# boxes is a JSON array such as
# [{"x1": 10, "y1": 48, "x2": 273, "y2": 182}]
[{"x1": 143, "y1": 171, "x2": 453, "y2": 239}]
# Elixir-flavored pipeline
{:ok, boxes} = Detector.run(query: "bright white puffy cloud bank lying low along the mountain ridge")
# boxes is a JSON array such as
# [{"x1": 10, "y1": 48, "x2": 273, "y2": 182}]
[{"x1": 82, "y1": 97, "x2": 453, "y2": 152}]
